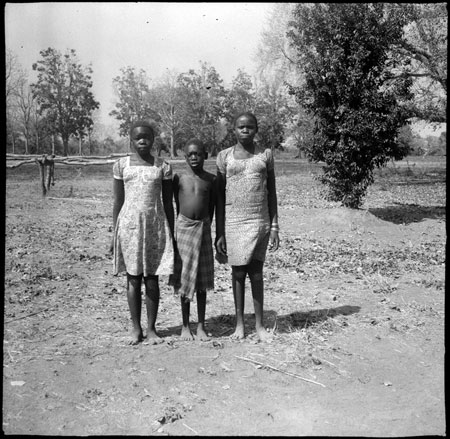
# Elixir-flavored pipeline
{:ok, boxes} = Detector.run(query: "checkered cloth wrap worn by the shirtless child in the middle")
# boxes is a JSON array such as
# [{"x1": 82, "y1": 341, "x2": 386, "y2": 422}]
[{"x1": 169, "y1": 214, "x2": 214, "y2": 300}]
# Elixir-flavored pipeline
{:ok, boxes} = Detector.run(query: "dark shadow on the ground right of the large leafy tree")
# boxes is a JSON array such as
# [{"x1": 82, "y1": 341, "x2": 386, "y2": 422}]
[{"x1": 369, "y1": 203, "x2": 445, "y2": 224}]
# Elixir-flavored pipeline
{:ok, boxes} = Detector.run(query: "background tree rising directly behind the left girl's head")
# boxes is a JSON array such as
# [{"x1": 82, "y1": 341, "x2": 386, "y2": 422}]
[{"x1": 109, "y1": 67, "x2": 158, "y2": 137}]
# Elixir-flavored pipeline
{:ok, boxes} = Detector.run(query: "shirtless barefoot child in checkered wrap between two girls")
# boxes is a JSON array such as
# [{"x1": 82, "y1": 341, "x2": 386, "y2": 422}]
[{"x1": 169, "y1": 139, "x2": 216, "y2": 340}]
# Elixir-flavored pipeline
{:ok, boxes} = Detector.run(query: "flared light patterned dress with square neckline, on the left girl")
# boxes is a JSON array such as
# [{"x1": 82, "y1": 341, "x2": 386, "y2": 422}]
[{"x1": 113, "y1": 156, "x2": 174, "y2": 276}]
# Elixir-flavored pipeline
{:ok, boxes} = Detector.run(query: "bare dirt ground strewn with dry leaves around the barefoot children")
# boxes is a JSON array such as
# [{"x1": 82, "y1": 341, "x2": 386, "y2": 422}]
[{"x1": 3, "y1": 159, "x2": 446, "y2": 437}]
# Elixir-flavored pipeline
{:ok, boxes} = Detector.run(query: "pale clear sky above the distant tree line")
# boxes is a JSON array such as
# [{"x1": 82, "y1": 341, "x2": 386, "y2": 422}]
[{"x1": 4, "y1": 2, "x2": 274, "y2": 123}]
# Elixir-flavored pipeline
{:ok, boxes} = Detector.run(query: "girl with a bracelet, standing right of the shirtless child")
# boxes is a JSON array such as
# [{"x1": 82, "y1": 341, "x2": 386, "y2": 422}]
[{"x1": 216, "y1": 112, "x2": 279, "y2": 341}]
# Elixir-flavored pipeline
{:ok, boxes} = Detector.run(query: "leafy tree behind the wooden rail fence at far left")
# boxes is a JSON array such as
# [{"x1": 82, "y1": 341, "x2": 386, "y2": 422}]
[{"x1": 31, "y1": 48, "x2": 99, "y2": 156}]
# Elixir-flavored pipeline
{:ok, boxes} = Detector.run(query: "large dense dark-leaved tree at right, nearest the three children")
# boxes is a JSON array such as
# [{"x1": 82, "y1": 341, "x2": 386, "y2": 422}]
[{"x1": 289, "y1": 3, "x2": 411, "y2": 208}]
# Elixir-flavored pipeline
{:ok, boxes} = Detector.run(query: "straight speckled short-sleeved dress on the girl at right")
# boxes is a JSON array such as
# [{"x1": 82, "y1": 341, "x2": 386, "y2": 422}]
[{"x1": 217, "y1": 146, "x2": 274, "y2": 265}]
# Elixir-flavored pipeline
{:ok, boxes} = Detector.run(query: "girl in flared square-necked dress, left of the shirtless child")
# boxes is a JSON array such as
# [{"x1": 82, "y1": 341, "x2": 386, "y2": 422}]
[{"x1": 112, "y1": 121, "x2": 174, "y2": 344}]
